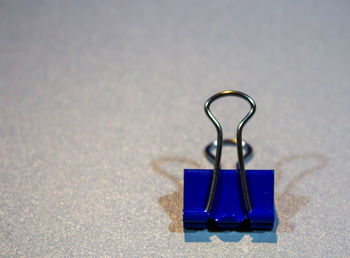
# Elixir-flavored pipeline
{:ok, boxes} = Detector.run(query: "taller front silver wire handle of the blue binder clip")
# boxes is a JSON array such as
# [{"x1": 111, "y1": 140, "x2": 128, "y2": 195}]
[{"x1": 204, "y1": 90, "x2": 256, "y2": 212}]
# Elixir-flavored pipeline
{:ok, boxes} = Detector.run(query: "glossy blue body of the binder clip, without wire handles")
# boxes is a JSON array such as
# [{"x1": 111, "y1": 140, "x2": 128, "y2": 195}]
[{"x1": 183, "y1": 169, "x2": 275, "y2": 229}]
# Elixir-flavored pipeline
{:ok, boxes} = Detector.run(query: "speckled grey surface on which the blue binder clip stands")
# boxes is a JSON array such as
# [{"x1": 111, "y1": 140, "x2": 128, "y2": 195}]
[{"x1": 0, "y1": 1, "x2": 350, "y2": 257}]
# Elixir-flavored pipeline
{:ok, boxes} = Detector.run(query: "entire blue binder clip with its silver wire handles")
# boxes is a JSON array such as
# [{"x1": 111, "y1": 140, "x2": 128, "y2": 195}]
[{"x1": 183, "y1": 91, "x2": 275, "y2": 230}]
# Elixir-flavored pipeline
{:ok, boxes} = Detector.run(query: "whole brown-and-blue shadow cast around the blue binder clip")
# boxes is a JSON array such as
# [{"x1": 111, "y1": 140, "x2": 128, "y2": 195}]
[{"x1": 151, "y1": 153, "x2": 328, "y2": 243}]
